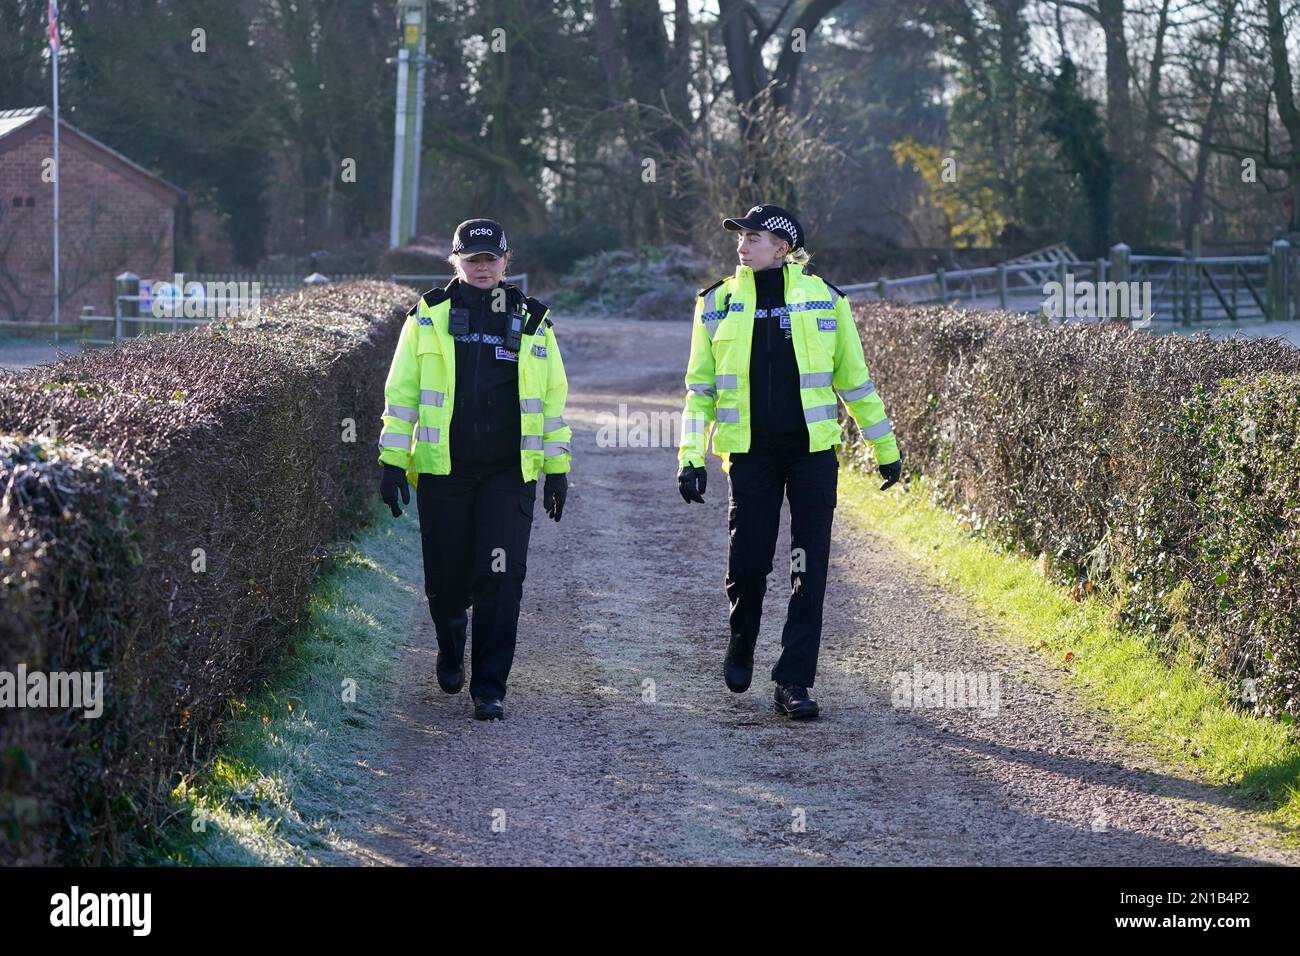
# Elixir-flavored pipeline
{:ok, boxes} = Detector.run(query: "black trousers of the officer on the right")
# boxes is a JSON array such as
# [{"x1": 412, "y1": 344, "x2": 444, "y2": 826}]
[{"x1": 727, "y1": 447, "x2": 840, "y2": 687}]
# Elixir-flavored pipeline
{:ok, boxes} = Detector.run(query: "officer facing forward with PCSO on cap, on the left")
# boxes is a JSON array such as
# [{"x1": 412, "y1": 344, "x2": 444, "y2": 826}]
[{"x1": 380, "y1": 219, "x2": 572, "y2": 721}]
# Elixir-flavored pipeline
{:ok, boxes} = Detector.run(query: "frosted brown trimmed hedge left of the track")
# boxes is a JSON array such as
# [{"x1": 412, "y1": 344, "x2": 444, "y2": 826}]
[{"x1": 0, "y1": 282, "x2": 412, "y2": 862}]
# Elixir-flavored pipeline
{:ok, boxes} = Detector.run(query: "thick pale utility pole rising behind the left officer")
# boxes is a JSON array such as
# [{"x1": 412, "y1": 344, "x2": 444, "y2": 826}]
[{"x1": 389, "y1": 0, "x2": 429, "y2": 248}]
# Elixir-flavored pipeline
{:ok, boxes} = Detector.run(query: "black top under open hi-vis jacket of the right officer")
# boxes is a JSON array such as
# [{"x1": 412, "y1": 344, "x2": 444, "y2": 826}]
[{"x1": 749, "y1": 265, "x2": 809, "y2": 453}]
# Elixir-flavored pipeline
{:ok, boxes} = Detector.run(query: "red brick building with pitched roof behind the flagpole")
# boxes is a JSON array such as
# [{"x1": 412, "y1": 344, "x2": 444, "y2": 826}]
[{"x1": 0, "y1": 107, "x2": 185, "y2": 321}]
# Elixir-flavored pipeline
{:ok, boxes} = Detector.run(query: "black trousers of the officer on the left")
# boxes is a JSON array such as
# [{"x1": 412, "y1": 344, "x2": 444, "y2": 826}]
[{"x1": 416, "y1": 459, "x2": 537, "y2": 698}]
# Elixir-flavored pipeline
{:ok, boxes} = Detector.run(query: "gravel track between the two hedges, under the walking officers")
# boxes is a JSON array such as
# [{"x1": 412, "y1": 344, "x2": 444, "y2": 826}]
[{"x1": 337, "y1": 319, "x2": 1297, "y2": 865}]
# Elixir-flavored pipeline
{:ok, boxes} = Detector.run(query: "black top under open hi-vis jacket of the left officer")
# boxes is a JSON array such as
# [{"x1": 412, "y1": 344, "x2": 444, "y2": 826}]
[{"x1": 447, "y1": 280, "x2": 524, "y2": 471}]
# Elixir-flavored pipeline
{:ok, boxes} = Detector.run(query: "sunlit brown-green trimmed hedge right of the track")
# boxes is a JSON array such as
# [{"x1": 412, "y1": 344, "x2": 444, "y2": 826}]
[{"x1": 854, "y1": 303, "x2": 1300, "y2": 722}]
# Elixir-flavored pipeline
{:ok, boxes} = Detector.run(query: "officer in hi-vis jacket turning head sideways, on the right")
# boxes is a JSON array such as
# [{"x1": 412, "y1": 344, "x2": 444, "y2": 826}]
[{"x1": 677, "y1": 203, "x2": 902, "y2": 719}]
